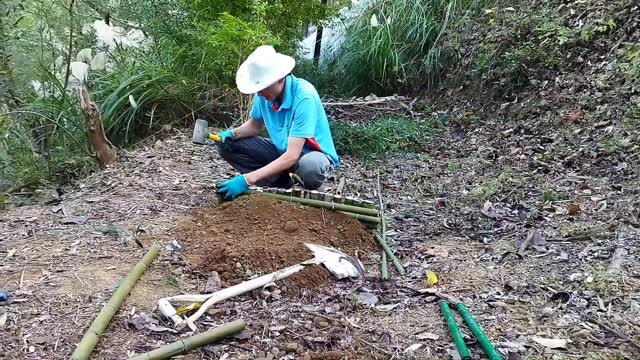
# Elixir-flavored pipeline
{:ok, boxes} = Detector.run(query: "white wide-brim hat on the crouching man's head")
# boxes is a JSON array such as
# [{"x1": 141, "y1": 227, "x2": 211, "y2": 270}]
[{"x1": 236, "y1": 45, "x2": 296, "y2": 94}]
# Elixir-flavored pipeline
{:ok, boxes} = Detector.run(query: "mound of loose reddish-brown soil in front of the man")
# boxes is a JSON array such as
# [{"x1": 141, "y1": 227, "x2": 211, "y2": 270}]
[{"x1": 176, "y1": 195, "x2": 375, "y2": 289}]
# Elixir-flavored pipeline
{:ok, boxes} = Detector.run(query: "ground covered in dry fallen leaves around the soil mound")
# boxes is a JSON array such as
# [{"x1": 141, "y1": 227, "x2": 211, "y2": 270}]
[{"x1": 0, "y1": 95, "x2": 640, "y2": 359}]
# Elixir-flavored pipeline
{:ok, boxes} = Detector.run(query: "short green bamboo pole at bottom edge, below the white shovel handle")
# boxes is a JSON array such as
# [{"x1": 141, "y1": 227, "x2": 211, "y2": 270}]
[{"x1": 129, "y1": 319, "x2": 245, "y2": 360}]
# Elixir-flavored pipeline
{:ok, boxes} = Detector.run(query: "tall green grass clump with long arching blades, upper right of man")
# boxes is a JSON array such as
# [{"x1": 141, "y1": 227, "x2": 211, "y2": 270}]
[{"x1": 330, "y1": 0, "x2": 459, "y2": 95}]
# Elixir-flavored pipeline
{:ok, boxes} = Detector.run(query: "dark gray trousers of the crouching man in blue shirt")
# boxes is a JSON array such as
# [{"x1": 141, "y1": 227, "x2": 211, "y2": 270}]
[{"x1": 217, "y1": 136, "x2": 333, "y2": 190}]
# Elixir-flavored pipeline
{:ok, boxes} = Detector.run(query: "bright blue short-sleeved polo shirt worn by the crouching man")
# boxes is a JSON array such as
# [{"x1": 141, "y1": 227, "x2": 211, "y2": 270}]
[{"x1": 251, "y1": 75, "x2": 340, "y2": 168}]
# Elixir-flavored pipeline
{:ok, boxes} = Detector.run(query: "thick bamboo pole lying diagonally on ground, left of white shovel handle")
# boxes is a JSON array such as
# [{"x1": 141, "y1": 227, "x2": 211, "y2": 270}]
[{"x1": 71, "y1": 246, "x2": 160, "y2": 360}]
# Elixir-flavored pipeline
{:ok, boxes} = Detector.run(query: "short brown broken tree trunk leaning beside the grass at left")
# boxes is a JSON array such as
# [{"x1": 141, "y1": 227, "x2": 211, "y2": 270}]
[{"x1": 80, "y1": 86, "x2": 117, "y2": 168}]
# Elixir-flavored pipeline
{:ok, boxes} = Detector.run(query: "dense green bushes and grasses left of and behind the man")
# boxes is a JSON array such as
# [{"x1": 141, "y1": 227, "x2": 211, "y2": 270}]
[{"x1": 0, "y1": 0, "x2": 333, "y2": 191}]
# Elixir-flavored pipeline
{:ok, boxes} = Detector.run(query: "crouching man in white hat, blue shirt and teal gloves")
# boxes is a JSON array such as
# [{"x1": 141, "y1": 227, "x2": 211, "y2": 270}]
[{"x1": 218, "y1": 45, "x2": 340, "y2": 199}]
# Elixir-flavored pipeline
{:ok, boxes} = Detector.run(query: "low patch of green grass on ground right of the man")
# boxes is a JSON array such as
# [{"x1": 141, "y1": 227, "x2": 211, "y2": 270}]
[{"x1": 331, "y1": 118, "x2": 434, "y2": 159}]
